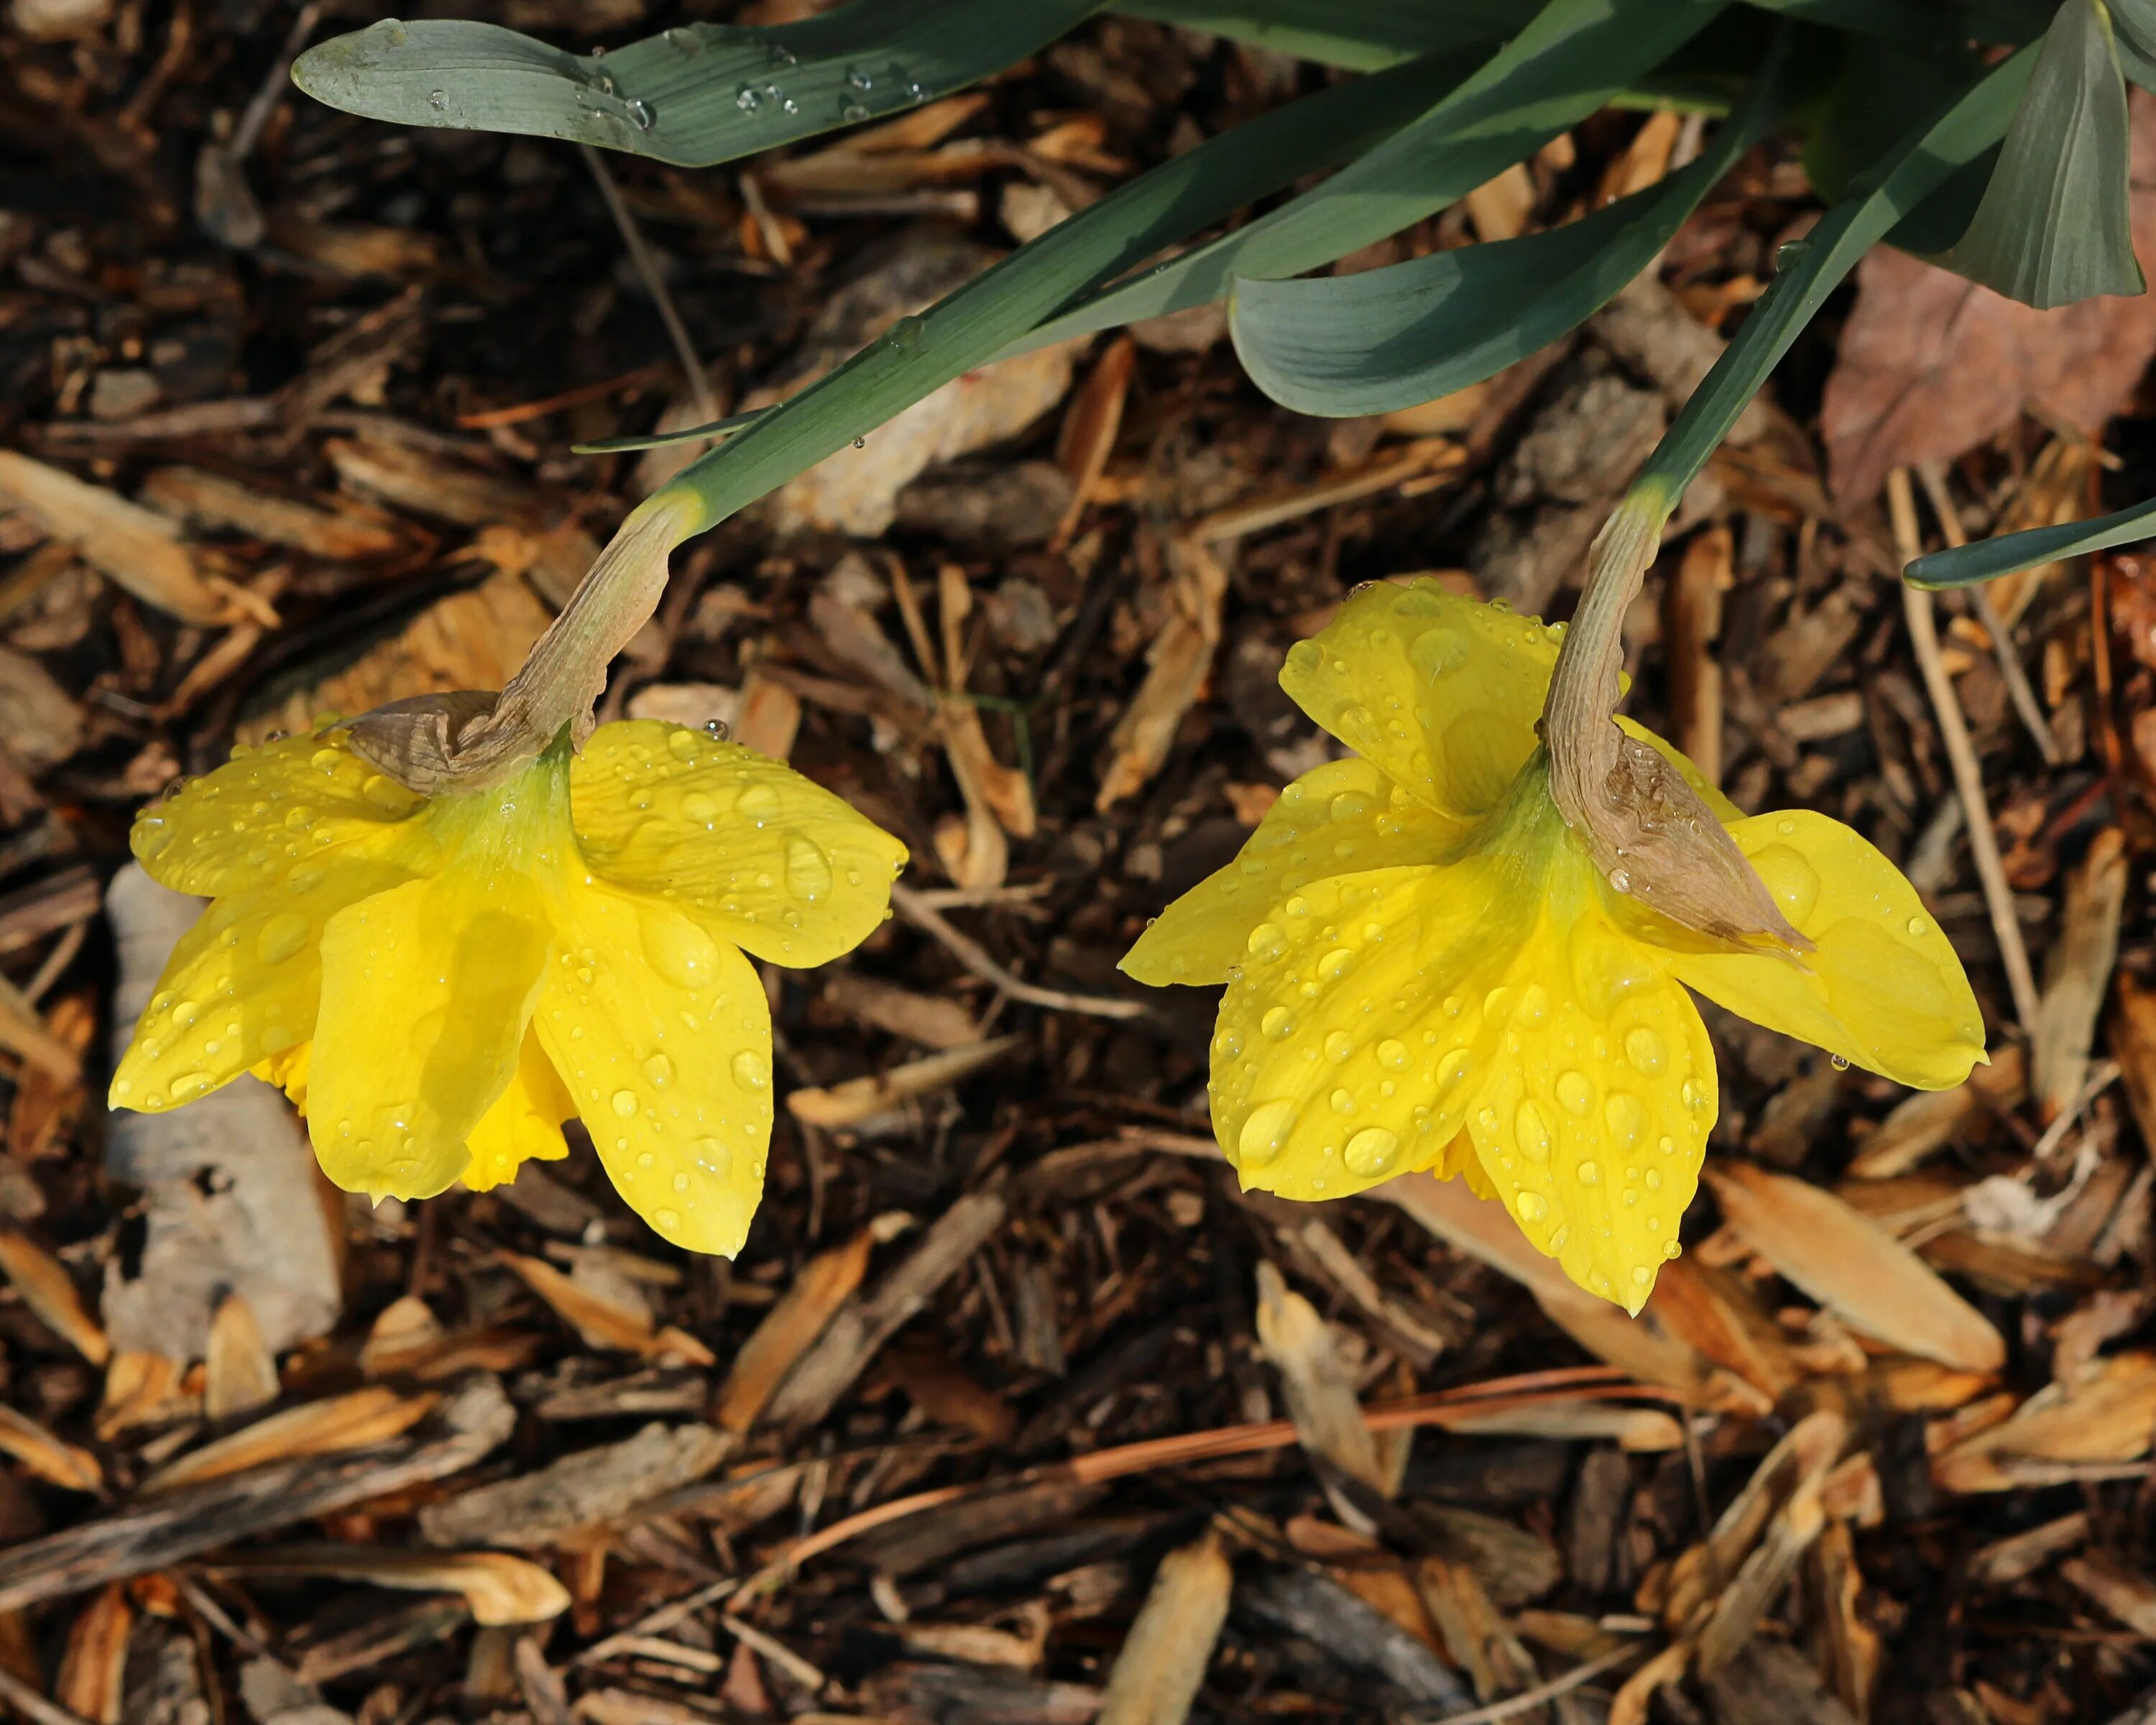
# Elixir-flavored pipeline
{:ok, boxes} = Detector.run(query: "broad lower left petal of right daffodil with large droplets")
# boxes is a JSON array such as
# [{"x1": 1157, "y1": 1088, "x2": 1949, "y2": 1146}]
[{"x1": 1212, "y1": 852, "x2": 1533, "y2": 1199}]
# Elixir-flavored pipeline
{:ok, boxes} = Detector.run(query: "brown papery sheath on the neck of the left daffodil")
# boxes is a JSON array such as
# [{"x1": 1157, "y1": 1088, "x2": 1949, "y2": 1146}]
[{"x1": 349, "y1": 487, "x2": 707, "y2": 796}]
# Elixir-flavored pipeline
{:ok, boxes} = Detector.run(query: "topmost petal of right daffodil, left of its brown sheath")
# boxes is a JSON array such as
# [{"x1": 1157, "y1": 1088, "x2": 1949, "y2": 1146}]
[{"x1": 1281, "y1": 576, "x2": 1559, "y2": 819}]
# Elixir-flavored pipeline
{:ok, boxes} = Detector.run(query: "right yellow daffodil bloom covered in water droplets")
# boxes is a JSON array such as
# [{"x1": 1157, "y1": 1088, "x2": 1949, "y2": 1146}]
[{"x1": 1123, "y1": 578, "x2": 1984, "y2": 1313}]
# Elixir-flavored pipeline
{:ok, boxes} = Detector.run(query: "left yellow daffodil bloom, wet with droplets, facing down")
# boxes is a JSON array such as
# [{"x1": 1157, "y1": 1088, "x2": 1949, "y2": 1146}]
[{"x1": 112, "y1": 720, "x2": 906, "y2": 1255}]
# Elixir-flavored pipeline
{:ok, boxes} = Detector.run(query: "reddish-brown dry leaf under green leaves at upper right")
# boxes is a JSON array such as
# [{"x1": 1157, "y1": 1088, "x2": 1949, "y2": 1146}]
[{"x1": 1820, "y1": 91, "x2": 2156, "y2": 502}]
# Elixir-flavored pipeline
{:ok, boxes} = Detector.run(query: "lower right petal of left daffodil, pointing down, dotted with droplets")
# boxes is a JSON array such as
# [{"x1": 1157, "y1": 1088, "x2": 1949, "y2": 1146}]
[{"x1": 535, "y1": 884, "x2": 772, "y2": 1257}]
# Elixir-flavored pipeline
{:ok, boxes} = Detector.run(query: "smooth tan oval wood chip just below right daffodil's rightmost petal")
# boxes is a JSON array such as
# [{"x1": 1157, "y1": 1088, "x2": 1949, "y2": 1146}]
[{"x1": 1705, "y1": 1162, "x2": 2007, "y2": 1371}]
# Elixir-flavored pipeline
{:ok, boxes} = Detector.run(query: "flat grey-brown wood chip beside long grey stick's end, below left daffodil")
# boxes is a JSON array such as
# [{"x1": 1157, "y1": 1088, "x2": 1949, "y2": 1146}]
[{"x1": 418, "y1": 1423, "x2": 737, "y2": 1548}]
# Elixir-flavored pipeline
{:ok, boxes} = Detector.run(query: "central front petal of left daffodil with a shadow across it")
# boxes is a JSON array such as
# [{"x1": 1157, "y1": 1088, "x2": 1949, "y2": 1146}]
[{"x1": 306, "y1": 867, "x2": 550, "y2": 1199}]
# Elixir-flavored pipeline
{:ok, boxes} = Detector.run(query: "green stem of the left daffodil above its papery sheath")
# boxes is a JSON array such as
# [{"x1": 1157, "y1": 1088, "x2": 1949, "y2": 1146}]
[{"x1": 671, "y1": 54, "x2": 1473, "y2": 524}]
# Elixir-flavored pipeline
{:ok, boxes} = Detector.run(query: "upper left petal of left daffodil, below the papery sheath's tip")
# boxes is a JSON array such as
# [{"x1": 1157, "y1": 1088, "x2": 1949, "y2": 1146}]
[{"x1": 129, "y1": 735, "x2": 431, "y2": 897}]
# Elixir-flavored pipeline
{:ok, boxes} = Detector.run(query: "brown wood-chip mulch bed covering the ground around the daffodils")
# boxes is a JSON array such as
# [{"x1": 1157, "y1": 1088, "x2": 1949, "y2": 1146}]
[{"x1": 0, "y1": 0, "x2": 2156, "y2": 1725}]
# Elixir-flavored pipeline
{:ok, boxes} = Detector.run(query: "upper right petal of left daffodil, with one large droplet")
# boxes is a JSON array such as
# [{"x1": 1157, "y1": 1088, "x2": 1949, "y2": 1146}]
[{"x1": 569, "y1": 720, "x2": 906, "y2": 966}]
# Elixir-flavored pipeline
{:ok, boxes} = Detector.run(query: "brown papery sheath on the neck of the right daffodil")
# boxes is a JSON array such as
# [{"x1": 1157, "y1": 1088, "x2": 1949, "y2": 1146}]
[{"x1": 1542, "y1": 479, "x2": 1811, "y2": 951}]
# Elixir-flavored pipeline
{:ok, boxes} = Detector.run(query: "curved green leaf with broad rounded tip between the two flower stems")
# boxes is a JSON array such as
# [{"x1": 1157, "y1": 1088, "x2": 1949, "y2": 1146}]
[{"x1": 1229, "y1": 43, "x2": 1787, "y2": 416}]
